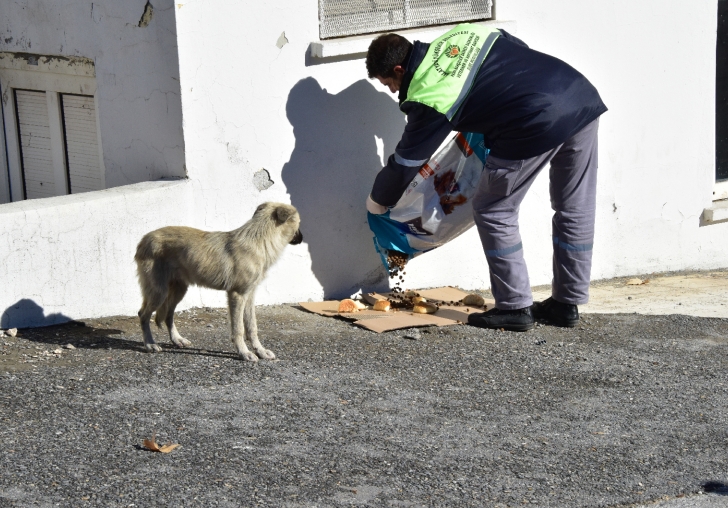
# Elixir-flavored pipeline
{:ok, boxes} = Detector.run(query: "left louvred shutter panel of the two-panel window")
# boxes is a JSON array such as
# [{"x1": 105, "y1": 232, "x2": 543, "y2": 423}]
[{"x1": 15, "y1": 90, "x2": 56, "y2": 199}]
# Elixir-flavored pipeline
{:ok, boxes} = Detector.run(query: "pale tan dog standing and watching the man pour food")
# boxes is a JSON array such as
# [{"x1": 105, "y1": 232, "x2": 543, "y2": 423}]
[{"x1": 134, "y1": 203, "x2": 303, "y2": 362}]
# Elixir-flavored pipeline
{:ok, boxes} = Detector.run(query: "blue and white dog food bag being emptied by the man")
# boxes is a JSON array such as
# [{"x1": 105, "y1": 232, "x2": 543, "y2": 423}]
[{"x1": 367, "y1": 132, "x2": 488, "y2": 269}]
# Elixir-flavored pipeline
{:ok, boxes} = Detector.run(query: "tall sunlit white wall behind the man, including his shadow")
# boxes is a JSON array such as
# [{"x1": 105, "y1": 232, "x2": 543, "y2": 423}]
[{"x1": 177, "y1": 0, "x2": 728, "y2": 298}]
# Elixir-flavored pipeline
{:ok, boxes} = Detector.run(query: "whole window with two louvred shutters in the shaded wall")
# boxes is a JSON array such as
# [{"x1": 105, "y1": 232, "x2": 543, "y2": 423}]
[{"x1": 0, "y1": 53, "x2": 105, "y2": 202}]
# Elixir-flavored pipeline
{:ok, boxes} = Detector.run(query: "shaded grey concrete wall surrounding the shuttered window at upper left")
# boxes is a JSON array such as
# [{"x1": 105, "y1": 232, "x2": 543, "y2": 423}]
[{"x1": 0, "y1": 0, "x2": 185, "y2": 187}]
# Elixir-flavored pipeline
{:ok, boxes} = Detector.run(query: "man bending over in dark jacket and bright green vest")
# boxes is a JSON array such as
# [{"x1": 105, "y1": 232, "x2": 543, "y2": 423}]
[{"x1": 366, "y1": 24, "x2": 607, "y2": 331}]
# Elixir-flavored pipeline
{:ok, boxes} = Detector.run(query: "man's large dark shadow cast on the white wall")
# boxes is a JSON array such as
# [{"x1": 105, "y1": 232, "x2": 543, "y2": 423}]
[{"x1": 281, "y1": 78, "x2": 405, "y2": 298}]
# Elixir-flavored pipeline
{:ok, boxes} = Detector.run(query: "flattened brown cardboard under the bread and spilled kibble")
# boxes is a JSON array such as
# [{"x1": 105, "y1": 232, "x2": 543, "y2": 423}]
[{"x1": 299, "y1": 287, "x2": 495, "y2": 333}]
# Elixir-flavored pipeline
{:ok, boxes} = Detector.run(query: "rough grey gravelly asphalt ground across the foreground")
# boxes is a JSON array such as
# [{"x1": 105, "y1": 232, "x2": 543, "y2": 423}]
[{"x1": 0, "y1": 305, "x2": 728, "y2": 507}]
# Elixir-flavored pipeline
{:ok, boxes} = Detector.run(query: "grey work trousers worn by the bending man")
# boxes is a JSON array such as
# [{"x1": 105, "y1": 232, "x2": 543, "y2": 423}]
[{"x1": 473, "y1": 119, "x2": 599, "y2": 310}]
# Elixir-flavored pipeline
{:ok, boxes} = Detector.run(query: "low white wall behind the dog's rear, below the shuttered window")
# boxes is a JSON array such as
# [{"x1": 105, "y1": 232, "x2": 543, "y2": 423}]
[{"x1": 0, "y1": 180, "x2": 195, "y2": 328}]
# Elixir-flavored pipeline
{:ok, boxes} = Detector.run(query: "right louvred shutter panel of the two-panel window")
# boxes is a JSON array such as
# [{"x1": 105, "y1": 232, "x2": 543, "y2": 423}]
[{"x1": 61, "y1": 94, "x2": 104, "y2": 194}]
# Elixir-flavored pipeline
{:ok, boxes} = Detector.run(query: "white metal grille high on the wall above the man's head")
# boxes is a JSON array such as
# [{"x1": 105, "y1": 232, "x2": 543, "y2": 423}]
[{"x1": 319, "y1": 0, "x2": 493, "y2": 39}]
